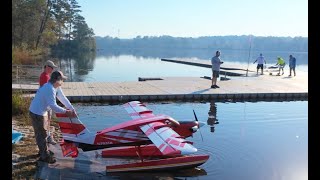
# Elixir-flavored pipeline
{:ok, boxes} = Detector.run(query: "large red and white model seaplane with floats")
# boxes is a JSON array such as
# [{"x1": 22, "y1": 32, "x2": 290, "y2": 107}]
[{"x1": 56, "y1": 101, "x2": 209, "y2": 172}]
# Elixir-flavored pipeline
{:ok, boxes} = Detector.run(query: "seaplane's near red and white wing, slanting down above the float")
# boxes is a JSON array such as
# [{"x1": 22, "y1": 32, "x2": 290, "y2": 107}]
[{"x1": 140, "y1": 122, "x2": 197, "y2": 155}]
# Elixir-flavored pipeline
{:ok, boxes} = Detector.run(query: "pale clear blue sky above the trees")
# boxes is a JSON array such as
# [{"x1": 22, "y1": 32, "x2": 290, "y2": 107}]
[{"x1": 77, "y1": 0, "x2": 308, "y2": 39}]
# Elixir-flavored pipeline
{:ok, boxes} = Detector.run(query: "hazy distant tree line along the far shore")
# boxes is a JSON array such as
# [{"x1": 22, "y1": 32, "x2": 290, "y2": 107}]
[{"x1": 96, "y1": 35, "x2": 308, "y2": 52}]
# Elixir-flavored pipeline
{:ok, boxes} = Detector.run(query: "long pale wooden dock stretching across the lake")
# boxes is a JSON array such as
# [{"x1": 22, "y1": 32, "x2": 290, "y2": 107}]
[{"x1": 12, "y1": 69, "x2": 308, "y2": 103}]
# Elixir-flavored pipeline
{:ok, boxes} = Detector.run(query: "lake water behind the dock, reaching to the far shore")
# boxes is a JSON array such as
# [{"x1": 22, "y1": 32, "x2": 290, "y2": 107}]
[{"x1": 60, "y1": 50, "x2": 308, "y2": 82}]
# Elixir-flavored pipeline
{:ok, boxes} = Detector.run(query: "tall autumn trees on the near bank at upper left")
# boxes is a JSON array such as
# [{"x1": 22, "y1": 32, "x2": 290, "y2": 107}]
[{"x1": 12, "y1": 0, "x2": 96, "y2": 63}]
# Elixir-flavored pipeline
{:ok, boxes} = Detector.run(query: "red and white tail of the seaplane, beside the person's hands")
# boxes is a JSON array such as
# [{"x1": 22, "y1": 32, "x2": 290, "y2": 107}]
[{"x1": 56, "y1": 113, "x2": 89, "y2": 158}]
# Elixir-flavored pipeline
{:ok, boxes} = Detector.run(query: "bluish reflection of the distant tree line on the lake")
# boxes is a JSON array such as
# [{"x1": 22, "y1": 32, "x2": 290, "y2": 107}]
[{"x1": 97, "y1": 48, "x2": 308, "y2": 65}]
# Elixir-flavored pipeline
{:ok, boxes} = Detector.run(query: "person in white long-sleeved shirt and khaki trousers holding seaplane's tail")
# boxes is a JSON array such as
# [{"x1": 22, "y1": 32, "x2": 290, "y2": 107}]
[{"x1": 29, "y1": 71, "x2": 74, "y2": 163}]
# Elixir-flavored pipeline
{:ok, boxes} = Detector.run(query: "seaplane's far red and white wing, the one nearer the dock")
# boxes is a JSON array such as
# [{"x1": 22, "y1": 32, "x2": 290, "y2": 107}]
[{"x1": 123, "y1": 101, "x2": 155, "y2": 119}]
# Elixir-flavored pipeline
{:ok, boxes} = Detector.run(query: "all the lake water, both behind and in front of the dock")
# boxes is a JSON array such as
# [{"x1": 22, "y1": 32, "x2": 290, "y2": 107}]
[{"x1": 55, "y1": 50, "x2": 308, "y2": 180}]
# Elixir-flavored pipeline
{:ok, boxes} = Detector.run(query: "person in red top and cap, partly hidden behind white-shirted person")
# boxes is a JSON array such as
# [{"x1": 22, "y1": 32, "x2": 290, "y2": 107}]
[{"x1": 39, "y1": 60, "x2": 58, "y2": 145}]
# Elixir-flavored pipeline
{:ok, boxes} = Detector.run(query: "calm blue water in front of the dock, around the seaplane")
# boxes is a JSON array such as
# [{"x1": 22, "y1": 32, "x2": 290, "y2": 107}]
[{"x1": 75, "y1": 101, "x2": 308, "y2": 180}]
